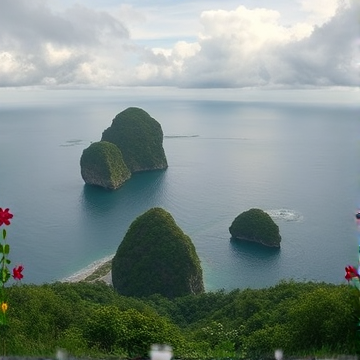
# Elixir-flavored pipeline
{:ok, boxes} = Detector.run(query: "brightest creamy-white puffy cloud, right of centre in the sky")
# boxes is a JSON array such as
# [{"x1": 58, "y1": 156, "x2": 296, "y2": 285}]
[{"x1": 146, "y1": 6, "x2": 313, "y2": 87}]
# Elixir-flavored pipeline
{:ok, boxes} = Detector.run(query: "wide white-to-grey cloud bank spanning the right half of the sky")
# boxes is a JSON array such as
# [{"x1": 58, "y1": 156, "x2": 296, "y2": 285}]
[{"x1": 140, "y1": 2, "x2": 359, "y2": 87}]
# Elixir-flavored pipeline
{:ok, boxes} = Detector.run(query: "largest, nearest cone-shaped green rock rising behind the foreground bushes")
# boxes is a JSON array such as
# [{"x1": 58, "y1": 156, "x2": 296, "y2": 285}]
[{"x1": 112, "y1": 208, "x2": 204, "y2": 298}]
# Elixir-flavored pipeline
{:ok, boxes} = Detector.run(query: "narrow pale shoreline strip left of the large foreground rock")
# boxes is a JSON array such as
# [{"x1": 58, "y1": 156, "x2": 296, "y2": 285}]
[{"x1": 59, "y1": 254, "x2": 115, "y2": 285}]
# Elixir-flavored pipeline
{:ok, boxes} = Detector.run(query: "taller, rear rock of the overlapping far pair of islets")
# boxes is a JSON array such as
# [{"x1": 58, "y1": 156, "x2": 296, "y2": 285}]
[{"x1": 101, "y1": 107, "x2": 168, "y2": 173}]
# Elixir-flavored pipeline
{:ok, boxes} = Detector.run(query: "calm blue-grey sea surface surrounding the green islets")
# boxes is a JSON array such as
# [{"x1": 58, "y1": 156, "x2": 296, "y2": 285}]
[{"x1": 0, "y1": 90, "x2": 360, "y2": 291}]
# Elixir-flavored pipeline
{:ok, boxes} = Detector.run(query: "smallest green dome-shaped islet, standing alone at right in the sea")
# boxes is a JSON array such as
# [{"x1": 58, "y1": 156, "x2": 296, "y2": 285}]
[{"x1": 229, "y1": 209, "x2": 281, "y2": 247}]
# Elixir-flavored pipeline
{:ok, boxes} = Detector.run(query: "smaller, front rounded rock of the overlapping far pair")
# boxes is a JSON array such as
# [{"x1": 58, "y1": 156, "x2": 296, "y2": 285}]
[{"x1": 80, "y1": 141, "x2": 131, "y2": 189}]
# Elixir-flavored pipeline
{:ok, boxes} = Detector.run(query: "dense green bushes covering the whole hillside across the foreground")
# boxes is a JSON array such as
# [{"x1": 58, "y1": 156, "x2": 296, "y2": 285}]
[{"x1": 0, "y1": 281, "x2": 359, "y2": 359}]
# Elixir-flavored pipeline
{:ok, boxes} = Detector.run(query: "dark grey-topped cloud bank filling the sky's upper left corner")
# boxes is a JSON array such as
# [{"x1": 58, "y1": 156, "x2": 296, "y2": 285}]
[{"x1": 0, "y1": 0, "x2": 128, "y2": 86}]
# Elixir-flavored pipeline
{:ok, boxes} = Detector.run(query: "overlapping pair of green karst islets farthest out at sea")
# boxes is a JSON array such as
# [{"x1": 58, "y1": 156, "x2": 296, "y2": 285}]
[{"x1": 80, "y1": 107, "x2": 168, "y2": 190}]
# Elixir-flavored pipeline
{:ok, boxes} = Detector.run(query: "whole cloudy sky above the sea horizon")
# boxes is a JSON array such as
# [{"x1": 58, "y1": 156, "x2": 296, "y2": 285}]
[{"x1": 0, "y1": 0, "x2": 360, "y2": 89}]
